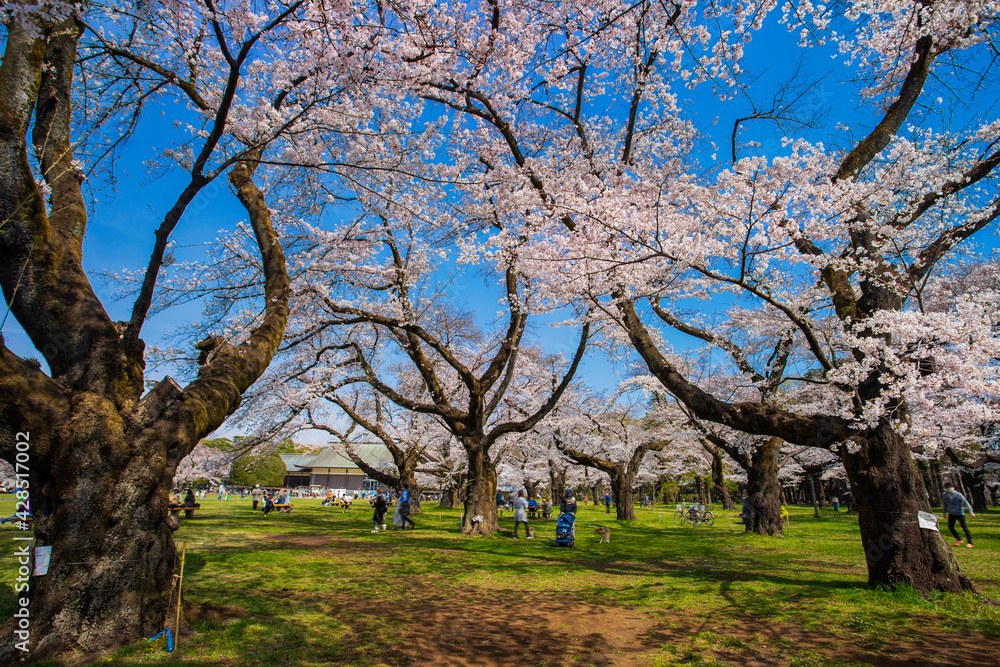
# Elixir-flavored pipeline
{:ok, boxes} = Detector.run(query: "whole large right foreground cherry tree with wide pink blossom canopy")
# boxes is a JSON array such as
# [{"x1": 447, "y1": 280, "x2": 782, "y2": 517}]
[{"x1": 374, "y1": 1, "x2": 1000, "y2": 591}]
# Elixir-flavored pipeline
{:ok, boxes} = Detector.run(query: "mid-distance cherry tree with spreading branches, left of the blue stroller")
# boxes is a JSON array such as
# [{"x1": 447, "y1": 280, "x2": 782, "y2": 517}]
[{"x1": 226, "y1": 200, "x2": 589, "y2": 535}]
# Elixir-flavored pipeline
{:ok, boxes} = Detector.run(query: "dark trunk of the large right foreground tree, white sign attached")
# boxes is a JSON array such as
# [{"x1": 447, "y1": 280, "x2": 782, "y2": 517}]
[{"x1": 841, "y1": 423, "x2": 973, "y2": 593}]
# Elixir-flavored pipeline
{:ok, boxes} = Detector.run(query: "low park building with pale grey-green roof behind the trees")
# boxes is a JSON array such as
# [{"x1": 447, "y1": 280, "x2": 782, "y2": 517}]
[{"x1": 281, "y1": 443, "x2": 393, "y2": 492}]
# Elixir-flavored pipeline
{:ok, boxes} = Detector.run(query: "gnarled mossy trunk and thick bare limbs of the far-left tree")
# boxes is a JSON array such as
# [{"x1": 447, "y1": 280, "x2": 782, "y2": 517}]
[{"x1": 0, "y1": 13, "x2": 289, "y2": 662}]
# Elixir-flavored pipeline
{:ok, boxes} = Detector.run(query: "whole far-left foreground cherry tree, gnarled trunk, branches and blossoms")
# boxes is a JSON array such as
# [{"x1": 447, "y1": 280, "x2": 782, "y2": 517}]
[{"x1": 0, "y1": 0, "x2": 382, "y2": 662}]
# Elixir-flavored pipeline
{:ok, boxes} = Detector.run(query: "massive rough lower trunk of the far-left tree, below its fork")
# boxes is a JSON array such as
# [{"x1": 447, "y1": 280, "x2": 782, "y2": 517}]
[{"x1": 0, "y1": 402, "x2": 176, "y2": 664}]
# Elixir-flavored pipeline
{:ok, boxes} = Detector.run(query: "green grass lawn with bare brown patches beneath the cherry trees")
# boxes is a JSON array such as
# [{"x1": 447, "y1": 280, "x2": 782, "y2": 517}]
[{"x1": 0, "y1": 496, "x2": 1000, "y2": 667}]
